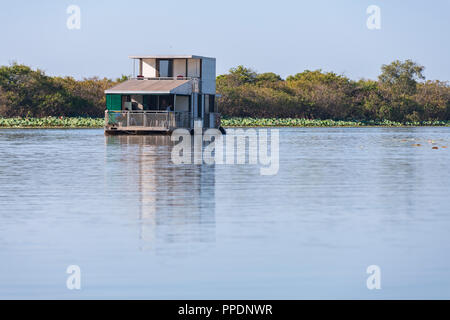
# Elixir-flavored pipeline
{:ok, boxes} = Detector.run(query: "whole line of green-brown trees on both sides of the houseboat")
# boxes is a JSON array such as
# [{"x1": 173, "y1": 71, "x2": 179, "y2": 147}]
[{"x1": 0, "y1": 60, "x2": 450, "y2": 122}]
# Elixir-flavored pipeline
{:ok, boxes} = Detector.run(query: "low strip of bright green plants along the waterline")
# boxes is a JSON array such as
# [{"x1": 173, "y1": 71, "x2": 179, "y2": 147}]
[{"x1": 0, "y1": 117, "x2": 450, "y2": 129}]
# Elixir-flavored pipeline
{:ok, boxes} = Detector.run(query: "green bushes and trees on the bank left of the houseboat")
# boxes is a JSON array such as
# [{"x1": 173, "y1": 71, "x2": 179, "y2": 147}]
[{"x1": 0, "y1": 64, "x2": 121, "y2": 118}]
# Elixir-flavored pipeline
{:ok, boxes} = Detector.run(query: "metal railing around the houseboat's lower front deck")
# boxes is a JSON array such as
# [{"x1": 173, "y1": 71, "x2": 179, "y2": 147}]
[{"x1": 105, "y1": 111, "x2": 192, "y2": 131}]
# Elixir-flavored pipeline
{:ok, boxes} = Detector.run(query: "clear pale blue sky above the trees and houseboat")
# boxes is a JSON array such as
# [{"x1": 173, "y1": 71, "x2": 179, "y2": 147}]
[{"x1": 0, "y1": 0, "x2": 450, "y2": 81}]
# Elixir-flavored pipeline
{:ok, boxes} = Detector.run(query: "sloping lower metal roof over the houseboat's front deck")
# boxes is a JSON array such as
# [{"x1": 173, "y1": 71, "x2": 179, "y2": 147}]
[{"x1": 105, "y1": 79, "x2": 192, "y2": 94}]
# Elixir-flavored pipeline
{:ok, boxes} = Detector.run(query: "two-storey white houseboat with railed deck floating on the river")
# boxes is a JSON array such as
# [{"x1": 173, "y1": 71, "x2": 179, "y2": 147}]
[{"x1": 105, "y1": 55, "x2": 223, "y2": 134}]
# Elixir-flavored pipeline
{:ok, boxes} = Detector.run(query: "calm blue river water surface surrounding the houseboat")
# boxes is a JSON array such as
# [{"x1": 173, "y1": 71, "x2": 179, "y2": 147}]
[{"x1": 0, "y1": 128, "x2": 450, "y2": 299}]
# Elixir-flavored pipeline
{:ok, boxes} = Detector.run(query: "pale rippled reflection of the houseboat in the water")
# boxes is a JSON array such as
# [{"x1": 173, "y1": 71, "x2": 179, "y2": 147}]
[{"x1": 106, "y1": 135, "x2": 216, "y2": 255}]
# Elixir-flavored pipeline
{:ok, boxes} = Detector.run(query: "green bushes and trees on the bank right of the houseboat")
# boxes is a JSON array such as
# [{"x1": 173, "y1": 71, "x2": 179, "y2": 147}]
[{"x1": 217, "y1": 60, "x2": 450, "y2": 123}]
